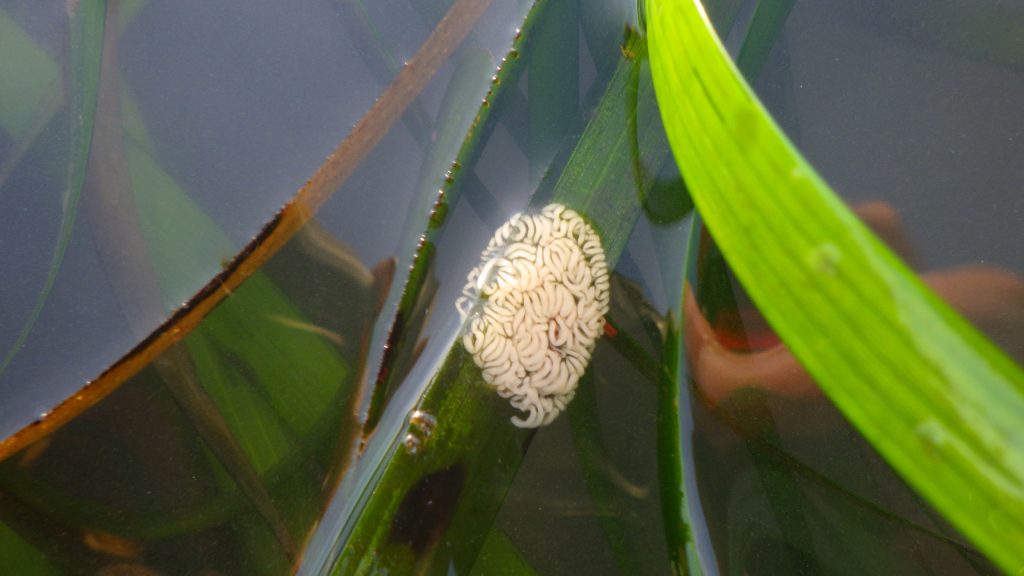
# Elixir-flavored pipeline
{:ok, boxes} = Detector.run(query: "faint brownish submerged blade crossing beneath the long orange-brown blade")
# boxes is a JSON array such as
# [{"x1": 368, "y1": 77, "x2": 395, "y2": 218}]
[{"x1": 83, "y1": 2, "x2": 296, "y2": 556}]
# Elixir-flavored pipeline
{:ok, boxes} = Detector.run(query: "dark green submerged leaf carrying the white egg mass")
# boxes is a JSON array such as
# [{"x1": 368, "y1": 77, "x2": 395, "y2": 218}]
[{"x1": 321, "y1": 31, "x2": 668, "y2": 574}]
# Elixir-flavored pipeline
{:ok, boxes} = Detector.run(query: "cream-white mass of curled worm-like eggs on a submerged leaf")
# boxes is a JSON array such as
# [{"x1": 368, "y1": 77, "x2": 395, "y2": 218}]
[{"x1": 456, "y1": 204, "x2": 609, "y2": 427}]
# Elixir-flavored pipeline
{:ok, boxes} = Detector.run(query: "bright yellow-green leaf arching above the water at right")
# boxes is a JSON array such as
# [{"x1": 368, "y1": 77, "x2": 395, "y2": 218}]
[{"x1": 647, "y1": 0, "x2": 1024, "y2": 572}]
